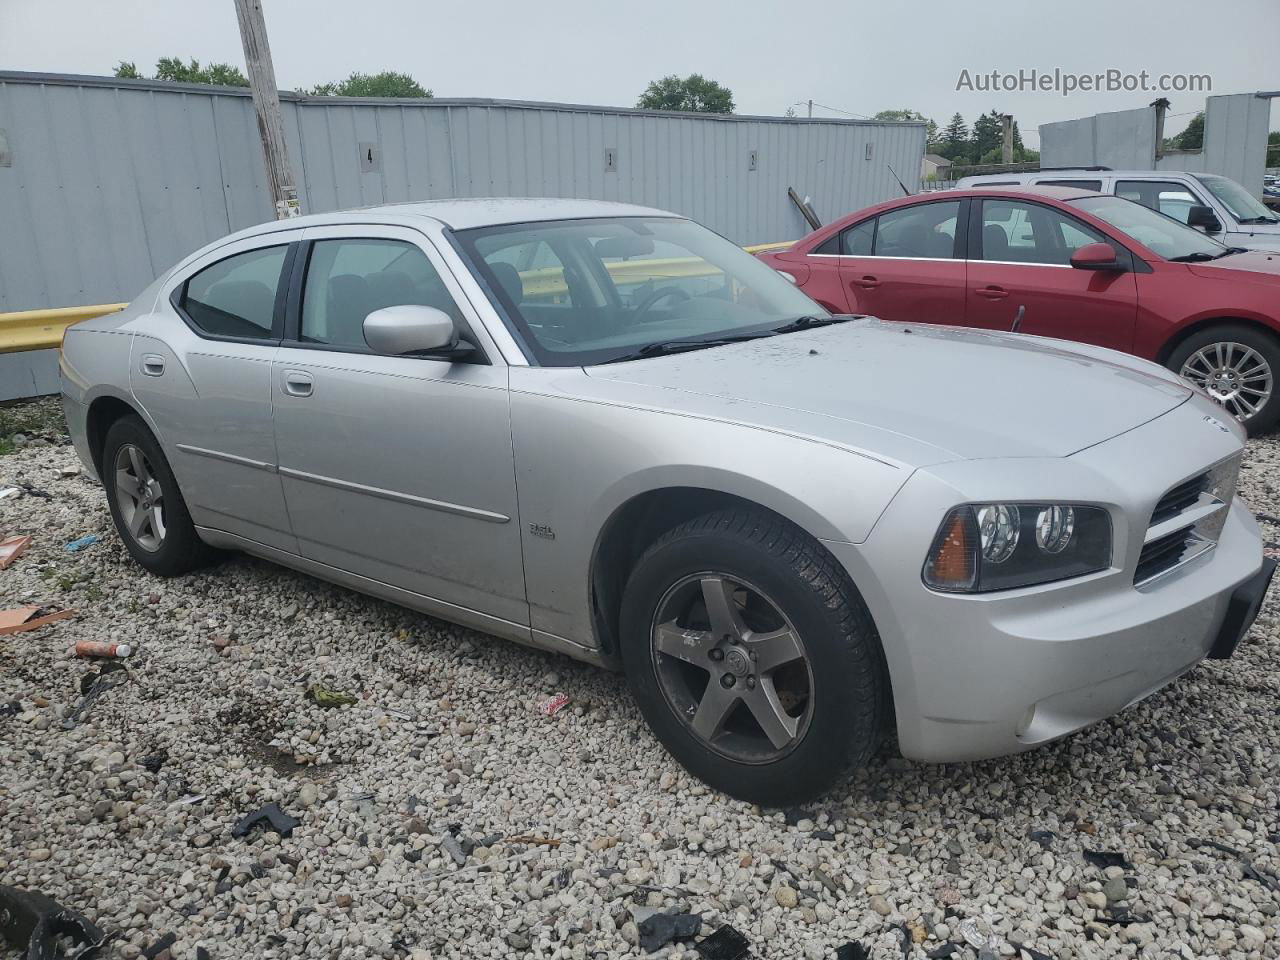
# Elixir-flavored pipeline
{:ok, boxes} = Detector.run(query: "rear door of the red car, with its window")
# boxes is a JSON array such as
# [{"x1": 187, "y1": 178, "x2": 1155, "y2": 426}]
[{"x1": 840, "y1": 200, "x2": 965, "y2": 324}]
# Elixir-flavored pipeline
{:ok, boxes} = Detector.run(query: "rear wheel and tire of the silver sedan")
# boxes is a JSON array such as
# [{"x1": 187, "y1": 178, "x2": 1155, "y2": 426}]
[{"x1": 100, "y1": 415, "x2": 215, "y2": 577}]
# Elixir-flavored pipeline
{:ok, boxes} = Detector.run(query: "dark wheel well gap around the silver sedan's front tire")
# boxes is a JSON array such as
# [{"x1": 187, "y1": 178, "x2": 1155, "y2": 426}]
[{"x1": 591, "y1": 486, "x2": 798, "y2": 664}]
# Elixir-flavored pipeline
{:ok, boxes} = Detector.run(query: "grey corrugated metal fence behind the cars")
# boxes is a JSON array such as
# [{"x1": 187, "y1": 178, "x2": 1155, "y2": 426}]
[{"x1": 0, "y1": 72, "x2": 924, "y2": 311}]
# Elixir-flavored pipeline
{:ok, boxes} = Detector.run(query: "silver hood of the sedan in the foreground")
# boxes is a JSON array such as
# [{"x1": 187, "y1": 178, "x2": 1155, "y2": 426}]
[{"x1": 585, "y1": 317, "x2": 1190, "y2": 466}]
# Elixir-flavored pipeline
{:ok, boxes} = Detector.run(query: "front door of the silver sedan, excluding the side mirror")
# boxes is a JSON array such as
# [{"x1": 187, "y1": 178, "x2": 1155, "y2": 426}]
[{"x1": 271, "y1": 225, "x2": 529, "y2": 626}]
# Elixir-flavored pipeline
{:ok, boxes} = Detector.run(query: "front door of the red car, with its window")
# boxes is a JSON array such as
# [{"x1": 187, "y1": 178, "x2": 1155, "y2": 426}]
[{"x1": 965, "y1": 200, "x2": 1138, "y2": 351}]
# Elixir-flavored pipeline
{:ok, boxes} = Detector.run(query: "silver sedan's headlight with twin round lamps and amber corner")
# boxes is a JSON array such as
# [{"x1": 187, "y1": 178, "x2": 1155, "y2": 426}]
[{"x1": 924, "y1": 503, "x2": 1111, "y2": 594}]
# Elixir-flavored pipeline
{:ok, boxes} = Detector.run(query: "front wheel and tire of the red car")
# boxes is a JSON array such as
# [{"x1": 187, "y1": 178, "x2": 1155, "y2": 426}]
[{"x1": 1166, "y1": 324, "x2": 1280, "y2": 436}]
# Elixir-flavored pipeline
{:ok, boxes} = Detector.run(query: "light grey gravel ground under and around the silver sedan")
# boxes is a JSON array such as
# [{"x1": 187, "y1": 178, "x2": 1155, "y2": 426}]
[{"x1": 0, "y1": 399, "x2": 1280, "y2": 960}]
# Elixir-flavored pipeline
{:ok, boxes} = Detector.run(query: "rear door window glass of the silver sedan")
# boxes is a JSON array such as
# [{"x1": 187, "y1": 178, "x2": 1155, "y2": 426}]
[{"x1": 177, "y1": 244, "x2": 289, "y2": 340}]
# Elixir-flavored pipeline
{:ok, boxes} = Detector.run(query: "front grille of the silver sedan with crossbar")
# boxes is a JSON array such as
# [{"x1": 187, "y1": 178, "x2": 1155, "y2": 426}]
[{"x1": 1133, "y1": 454, "x2": 1242, "y2": 586}]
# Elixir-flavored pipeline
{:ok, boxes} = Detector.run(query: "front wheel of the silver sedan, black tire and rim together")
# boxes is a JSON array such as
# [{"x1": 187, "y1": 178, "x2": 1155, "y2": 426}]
[{"x1": 621, "y1": 508, "x2": 890, "y2": 806}]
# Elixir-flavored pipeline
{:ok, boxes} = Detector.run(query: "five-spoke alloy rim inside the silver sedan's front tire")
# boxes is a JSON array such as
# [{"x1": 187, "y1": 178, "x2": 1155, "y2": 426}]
[{"x1": 650, "y1": 572, "x2": 814, "y2": 763}]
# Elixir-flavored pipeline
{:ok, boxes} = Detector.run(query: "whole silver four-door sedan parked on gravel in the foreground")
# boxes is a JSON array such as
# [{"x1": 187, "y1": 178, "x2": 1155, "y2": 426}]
[{"x1": 63, "y1": 200, "x2": 1272, "y2": 804}]
